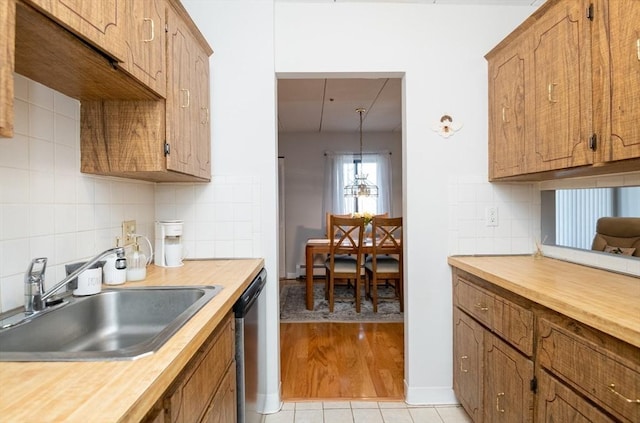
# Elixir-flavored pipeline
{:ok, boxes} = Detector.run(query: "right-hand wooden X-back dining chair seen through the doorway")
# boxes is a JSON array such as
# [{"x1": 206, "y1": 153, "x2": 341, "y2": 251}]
[{"x1": 364, "y1": 217, "x2": 404, "y2": 313}]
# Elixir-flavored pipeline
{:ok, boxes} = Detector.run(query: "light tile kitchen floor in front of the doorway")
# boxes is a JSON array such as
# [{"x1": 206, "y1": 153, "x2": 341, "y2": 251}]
[{"x1": 264, "y1": 401, "x2": 471, "y2": 423}]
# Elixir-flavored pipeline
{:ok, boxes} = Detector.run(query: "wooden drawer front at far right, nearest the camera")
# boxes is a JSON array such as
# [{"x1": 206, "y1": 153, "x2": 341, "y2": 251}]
[{"x1": 538, "y1": 319, "x2": 640, "y2": 422}]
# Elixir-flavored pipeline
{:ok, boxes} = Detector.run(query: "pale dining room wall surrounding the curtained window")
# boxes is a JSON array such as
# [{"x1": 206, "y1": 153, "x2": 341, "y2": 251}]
[{"x1": 278, "y1": 132, "x2": 403, "y2": 278}]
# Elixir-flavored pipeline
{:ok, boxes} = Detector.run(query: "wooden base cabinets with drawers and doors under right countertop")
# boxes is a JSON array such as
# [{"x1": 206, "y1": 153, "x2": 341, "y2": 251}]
[{"x1": 453, "y1": 267, "x2": 640, "y2": 423}]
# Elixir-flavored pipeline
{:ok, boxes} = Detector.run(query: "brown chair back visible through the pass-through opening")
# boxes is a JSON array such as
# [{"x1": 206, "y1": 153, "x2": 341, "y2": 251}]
[{"x1": 591, "y1": 217, "x2": 640, "y2": 257}]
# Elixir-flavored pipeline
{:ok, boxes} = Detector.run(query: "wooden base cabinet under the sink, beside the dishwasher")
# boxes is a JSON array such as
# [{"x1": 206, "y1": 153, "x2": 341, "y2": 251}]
[{"x1": 143, "y1": 313, "x2": 237, "y2": 423}]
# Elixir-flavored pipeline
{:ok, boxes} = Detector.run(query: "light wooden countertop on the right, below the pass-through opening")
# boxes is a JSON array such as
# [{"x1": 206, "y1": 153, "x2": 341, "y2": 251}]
[{"x1": 448, "y1": 256, "x2": 640, "y2": 348}]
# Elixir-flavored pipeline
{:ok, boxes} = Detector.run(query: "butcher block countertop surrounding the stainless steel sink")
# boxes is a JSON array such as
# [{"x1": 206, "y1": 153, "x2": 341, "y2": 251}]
[{"x1": 0, "y1": 259, "x2": 264, "y2": 423}]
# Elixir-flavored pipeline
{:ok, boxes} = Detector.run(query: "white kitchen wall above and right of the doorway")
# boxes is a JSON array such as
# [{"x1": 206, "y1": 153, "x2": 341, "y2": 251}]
[{"x1": 275, "y1": 2, "x2": 537, "y2": 404}]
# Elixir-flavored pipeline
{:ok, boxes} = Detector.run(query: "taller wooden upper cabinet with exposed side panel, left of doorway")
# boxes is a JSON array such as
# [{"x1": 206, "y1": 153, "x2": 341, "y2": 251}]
[{"x1": 80, "y1": 0, "x2": 212, "y2": 182}]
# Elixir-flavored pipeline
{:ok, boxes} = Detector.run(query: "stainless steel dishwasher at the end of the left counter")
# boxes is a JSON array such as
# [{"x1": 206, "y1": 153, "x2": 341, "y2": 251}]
[{"x1": 233, "y1": 269, "x2": 267, "y2": 423}]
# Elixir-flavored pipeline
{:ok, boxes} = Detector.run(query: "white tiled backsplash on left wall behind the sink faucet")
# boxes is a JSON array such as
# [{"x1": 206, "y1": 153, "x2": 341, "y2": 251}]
[{"x1": 0, "y1": 75, "x2": 154, "y2": 311}]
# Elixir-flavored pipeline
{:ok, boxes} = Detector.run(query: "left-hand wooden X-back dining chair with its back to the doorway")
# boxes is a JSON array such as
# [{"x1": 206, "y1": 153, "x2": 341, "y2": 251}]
[{"x1": 325, "y1": 216, "x2": 364, "y2": 313}]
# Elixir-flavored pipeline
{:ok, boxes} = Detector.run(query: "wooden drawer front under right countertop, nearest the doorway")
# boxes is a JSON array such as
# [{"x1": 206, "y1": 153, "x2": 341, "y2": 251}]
[{"x1": 454, "y1": 277, "x2": 533, "y2": 357}]
